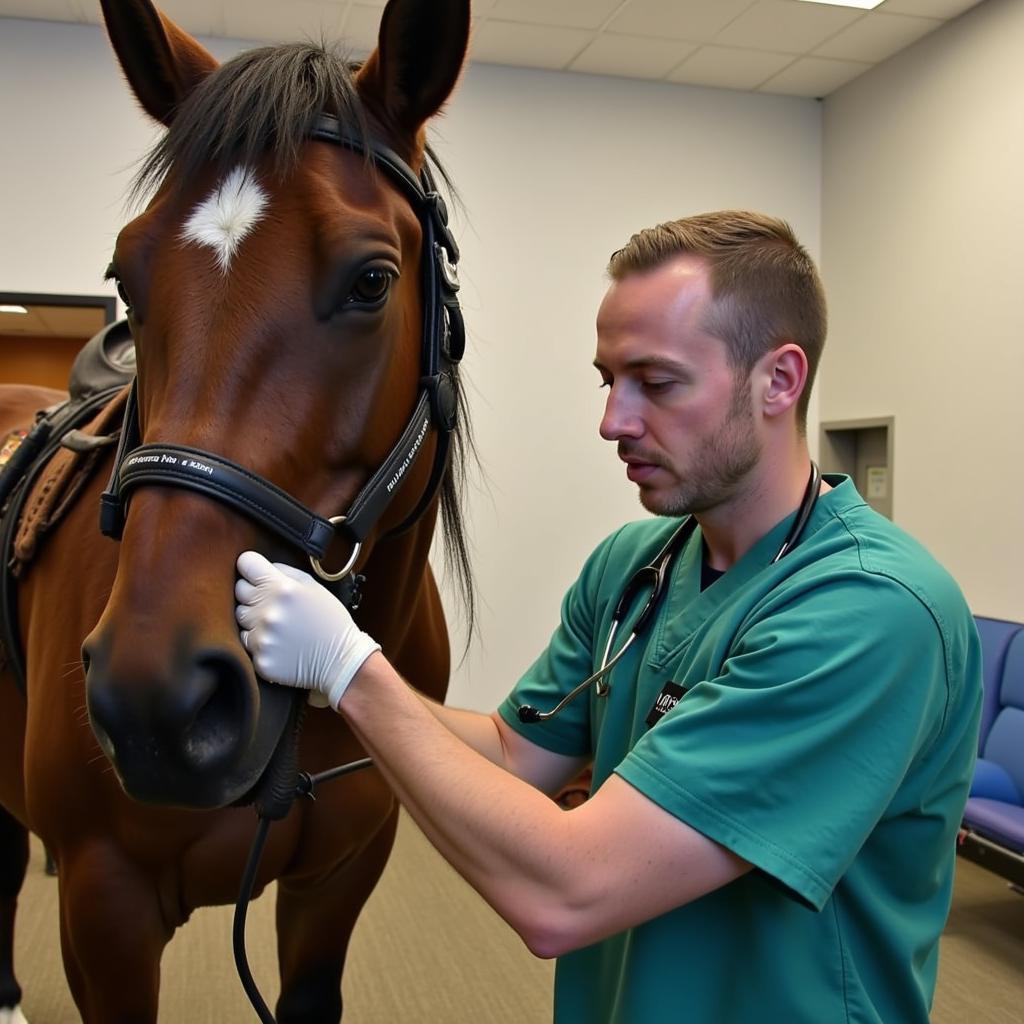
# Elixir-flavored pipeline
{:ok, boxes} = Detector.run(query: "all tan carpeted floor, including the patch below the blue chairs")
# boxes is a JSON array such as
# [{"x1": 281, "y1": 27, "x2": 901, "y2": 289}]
[{"x1": 9, "y1": 818, "x2": 1024, "y2": 1024}]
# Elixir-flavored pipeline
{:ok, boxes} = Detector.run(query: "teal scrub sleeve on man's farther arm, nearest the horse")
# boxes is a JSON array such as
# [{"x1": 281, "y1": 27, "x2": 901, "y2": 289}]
[{"x1": 498, "y1": 527, "x2": 627, "y2": 757}]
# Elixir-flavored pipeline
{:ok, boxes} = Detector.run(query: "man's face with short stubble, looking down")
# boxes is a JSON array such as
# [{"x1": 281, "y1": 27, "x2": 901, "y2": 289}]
[{"x1": 594, "y1": 256, "x2": 761, "y2": 515}]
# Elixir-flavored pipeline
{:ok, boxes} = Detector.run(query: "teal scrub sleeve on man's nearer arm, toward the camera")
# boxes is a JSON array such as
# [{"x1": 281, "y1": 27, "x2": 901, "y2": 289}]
[{"x1": 616, "y1": 573, "x2": 949, "y2": 909}]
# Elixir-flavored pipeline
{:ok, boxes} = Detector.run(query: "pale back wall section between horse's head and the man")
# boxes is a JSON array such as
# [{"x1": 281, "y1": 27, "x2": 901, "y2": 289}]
[{"x1": 441, "y1": 68, "x2": 820, "y2": 707}]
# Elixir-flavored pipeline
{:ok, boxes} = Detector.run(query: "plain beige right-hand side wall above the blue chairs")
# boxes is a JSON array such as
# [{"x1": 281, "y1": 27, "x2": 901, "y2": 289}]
[{"x1": 819, "y1": 0, "x2": 1024, "y2": 620}]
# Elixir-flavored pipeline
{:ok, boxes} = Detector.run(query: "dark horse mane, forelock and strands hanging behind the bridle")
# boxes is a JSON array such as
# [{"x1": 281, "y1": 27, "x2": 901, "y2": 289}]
[{"x1": 129, "y1": 42, "x2": 476, "y2": 647}]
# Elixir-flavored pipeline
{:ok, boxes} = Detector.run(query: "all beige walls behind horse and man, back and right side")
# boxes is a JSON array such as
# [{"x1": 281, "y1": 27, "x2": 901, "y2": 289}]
[{"x1": 0, "y1": 0, "x2": 1024, "y2": 708}]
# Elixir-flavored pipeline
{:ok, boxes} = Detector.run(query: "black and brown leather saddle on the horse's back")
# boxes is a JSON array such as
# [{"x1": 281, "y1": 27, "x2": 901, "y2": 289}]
[{"x1": 0, "y1": 321, "x2": 135, "y2": 689}]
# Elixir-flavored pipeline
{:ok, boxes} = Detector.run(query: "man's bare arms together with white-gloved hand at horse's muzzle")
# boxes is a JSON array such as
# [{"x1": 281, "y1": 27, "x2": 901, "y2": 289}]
[{"x1": 236, "y1": 552, "x2": 750, "y2": 956}]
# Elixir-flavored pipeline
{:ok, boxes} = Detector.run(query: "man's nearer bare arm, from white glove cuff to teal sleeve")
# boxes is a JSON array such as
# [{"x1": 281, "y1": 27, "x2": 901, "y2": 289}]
[{"x1": 341, "y1": 653, "x2": 751, "y2": 956}]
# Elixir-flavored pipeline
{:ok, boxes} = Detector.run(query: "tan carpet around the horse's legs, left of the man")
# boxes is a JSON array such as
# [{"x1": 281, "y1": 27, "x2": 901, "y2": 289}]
[{"x1": 15, "y1": 817, "x2": 554, "y2": 1024}]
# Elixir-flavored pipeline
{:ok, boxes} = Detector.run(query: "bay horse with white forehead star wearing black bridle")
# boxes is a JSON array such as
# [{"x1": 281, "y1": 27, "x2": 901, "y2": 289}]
[{"x1": 0, "y1": 0, "x2": 472, "y2": 1024}]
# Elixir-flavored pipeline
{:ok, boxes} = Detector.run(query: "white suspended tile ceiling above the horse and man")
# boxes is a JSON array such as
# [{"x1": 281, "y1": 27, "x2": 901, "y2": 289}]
[{"x1": 0, "y1": 0, "x2": 980, "y2": 97}]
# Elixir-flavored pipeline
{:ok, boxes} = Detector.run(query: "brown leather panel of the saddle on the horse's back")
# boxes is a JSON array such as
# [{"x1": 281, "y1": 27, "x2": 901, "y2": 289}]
[{"x1": 10, "y1": 389, "x2": 128, "y2": 577}]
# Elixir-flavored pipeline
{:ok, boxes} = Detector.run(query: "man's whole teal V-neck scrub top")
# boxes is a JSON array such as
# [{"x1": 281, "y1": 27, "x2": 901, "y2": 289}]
[{"x1": 500, "y1": 477, "x2": 982, "y2": 1024}]
